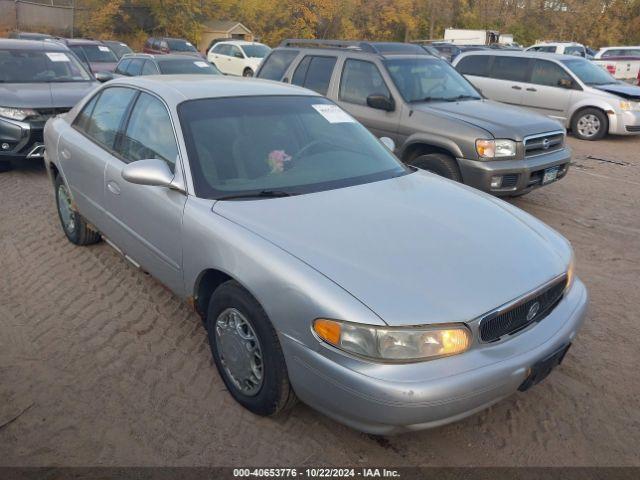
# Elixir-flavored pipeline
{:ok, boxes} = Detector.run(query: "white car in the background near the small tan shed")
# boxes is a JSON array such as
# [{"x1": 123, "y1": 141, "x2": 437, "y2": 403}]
[{"x1": 207, "y1": 40, "x2": 271, "y2": 77}]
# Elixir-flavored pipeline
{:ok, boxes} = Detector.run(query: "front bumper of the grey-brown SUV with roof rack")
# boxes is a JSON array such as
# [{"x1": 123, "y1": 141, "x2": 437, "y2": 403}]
[{"x1": 457, "y1": 147, "x2": 571, "y2": 196}]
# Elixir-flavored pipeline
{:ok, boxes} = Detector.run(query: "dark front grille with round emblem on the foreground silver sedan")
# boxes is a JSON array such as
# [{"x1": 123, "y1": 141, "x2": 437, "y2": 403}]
[{"x1": 480, "y1": 277, "x2": 567, "y2": 342}]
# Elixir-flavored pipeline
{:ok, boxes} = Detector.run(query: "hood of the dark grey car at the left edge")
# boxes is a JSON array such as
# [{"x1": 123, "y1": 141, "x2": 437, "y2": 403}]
[{"x1": 0, "y1": 82, "x2": 99, "y2": 108}]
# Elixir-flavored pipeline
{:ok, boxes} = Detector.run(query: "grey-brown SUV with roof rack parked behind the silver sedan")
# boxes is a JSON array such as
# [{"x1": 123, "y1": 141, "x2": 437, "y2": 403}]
[{"x1": 257, "y1": 40, "x2": 571, "y2": 196}]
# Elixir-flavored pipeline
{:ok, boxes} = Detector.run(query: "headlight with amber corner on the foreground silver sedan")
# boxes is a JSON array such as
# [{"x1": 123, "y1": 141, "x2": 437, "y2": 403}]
[{"x1": 313, "y1": 318, "x2": 471, "y2": 362}]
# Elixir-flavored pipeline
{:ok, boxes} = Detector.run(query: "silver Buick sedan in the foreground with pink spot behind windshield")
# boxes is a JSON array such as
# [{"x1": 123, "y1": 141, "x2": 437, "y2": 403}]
[{"x1": 45, "y1": 76, "x2": 587, "y2": 434}]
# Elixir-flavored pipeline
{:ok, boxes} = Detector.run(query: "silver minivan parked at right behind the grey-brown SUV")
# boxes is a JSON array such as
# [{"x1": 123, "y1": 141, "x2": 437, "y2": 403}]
[{"x1": 453, "y1": 51, "x2": 640, "y2": 140}]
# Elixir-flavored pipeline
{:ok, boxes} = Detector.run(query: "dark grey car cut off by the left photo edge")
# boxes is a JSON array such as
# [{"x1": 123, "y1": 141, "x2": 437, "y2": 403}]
[{"x1": 0, "y1": 39, "x2": 98, "y2": 170}]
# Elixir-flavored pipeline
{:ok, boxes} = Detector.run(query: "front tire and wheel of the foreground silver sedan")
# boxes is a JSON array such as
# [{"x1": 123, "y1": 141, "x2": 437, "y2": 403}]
[{"x1": 206, "y1": 280, "x2": 296, "y2": 416}]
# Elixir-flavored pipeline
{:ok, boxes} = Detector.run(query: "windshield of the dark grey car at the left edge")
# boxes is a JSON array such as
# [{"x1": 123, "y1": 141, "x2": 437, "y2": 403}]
[{"x1": 0, "y1": 49, "x2": 92, "y2": 83}]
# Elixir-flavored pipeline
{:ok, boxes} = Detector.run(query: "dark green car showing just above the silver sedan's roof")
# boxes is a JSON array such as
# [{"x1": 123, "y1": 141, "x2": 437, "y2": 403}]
[{"x1": 115, "y1": 53, "x2": 222, "y2": 77}]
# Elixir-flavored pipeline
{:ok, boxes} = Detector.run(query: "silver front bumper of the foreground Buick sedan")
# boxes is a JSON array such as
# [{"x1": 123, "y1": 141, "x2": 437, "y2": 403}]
[{"x1": 282, "y1": 279, "x2": 588, "y2": 435}]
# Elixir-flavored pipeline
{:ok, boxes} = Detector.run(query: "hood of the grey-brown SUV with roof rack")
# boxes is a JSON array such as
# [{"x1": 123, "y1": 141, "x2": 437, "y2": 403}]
[{"x1": 411, "y1": 100, "x2": 563, "y2": 141}]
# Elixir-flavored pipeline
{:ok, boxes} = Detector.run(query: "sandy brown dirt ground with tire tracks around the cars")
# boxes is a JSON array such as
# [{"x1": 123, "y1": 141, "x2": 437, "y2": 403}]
[{"x1": 0, "y1": 138, "x2": 640, "y2": 466}]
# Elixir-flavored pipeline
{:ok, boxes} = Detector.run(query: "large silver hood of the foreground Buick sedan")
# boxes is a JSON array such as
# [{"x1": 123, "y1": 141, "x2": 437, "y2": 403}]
[{"x1": 213, "y1": 172, "x2": 570, "y2": 325}]
